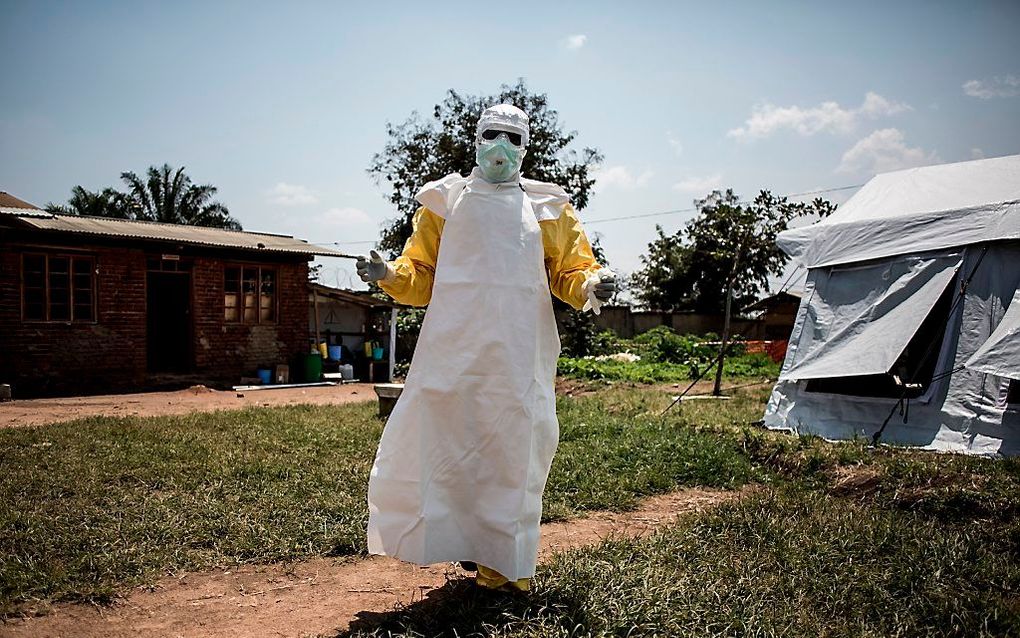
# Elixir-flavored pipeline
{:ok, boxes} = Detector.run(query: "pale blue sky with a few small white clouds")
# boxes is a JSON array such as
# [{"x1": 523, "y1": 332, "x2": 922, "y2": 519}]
[{"x1": 0, "y1": 1, "x2": 1020, "y2": 285}]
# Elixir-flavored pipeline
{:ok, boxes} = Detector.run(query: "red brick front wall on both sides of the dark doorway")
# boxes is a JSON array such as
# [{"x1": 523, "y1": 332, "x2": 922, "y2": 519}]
[{"x1": 0, "y1": 240, "x2": 308, "y2": 398}]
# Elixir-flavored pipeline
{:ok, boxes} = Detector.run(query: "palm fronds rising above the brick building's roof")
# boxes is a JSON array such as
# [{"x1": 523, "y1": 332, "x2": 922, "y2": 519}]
[{"x1": 46, "y1": 164, "x2": 241, "y2": 231}]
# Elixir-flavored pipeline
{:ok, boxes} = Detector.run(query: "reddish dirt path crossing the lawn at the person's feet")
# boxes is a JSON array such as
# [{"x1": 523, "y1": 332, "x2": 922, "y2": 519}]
[{"x1": 0, "y1": 489, "x2": 740, "y2": 638}]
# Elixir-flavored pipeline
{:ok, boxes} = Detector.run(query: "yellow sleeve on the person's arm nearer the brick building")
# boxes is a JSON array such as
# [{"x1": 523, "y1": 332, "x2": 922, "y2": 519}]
[{"x1": 379, "y1": 206, "x2": 446, "y2": 305}]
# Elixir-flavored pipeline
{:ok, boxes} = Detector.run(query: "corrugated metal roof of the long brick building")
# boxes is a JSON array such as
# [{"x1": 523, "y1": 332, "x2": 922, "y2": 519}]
[{"x1": 0, "y1": 205, "x2": 352, "y2": 257}]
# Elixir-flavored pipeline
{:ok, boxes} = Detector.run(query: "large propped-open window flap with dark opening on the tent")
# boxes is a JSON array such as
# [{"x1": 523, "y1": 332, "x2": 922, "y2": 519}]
[{"x1": 781, "y1": 253, "x2": 961, "y2": 396}]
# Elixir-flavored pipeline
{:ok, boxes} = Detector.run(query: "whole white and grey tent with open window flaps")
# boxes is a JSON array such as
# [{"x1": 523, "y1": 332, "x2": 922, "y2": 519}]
[{"x1": 765, "y1": 155, "x2": 1020, "y2": 455}]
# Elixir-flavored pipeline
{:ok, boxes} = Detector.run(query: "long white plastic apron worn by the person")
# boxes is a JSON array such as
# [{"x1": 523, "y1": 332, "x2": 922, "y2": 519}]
[{"x1": 368, "y1": 171, "x2": 560, "y2": 581}]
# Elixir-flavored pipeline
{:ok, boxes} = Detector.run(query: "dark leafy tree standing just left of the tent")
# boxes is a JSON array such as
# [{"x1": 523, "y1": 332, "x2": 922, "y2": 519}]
[{"x1": 631, "y1": 190, "x2": 835, "y2": 313}]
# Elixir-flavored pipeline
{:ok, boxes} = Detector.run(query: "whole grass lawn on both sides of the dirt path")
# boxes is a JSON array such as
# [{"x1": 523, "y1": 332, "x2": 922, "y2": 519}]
[{"x1": 0, "y1": 379, "x2": 1020, "y2": 636}]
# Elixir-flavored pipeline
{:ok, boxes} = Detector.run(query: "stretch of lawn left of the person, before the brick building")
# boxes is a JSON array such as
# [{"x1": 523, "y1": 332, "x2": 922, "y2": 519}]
[{"x1": 0, "y1": 403, "x2": 381, "y2": 612}]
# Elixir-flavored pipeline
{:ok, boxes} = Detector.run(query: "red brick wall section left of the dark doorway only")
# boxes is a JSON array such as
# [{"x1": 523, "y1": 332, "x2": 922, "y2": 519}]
[{"x1": 0, "y1": 244, "x2": 145, "y2": 398}]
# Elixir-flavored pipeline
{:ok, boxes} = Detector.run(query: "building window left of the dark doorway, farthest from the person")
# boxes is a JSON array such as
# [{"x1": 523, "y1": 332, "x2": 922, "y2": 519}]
[{"x1": 21, "y1": 254, "x2": 96, "y2": 323}]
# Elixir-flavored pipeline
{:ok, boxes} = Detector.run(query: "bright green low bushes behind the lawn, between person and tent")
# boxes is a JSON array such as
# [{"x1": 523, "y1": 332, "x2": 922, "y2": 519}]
[{"x1": 557, "y1": 327, "x2": 779, "y2": 383}]
